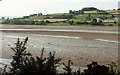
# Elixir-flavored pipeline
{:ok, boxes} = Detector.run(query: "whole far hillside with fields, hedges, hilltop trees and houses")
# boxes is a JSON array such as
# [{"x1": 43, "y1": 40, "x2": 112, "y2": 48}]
[{"x1": 2, "y1": 7, "x2": 120, "y2": 26}]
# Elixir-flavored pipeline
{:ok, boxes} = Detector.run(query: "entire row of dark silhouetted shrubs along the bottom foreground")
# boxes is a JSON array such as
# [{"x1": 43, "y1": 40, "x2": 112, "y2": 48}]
[{"x1": 2, "y1": 37, "x2": 120, "y2": 75}]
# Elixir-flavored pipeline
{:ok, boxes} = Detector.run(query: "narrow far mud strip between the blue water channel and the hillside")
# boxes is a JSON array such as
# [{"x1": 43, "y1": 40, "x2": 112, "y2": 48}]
[{"x1": 0, "y1": 25, "x2": 119, "y2": 31}]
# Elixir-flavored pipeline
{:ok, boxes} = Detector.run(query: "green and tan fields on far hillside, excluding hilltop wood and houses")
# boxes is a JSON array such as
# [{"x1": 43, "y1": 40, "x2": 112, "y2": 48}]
[{"x1": 2, "y1": 10, "x2": 119, "y2": 26}]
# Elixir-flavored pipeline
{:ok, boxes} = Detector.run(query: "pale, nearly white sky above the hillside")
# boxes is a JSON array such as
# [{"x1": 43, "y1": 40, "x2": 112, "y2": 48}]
[{"x1": 0, "y1": 0, "x2": 119, "y2": 17}]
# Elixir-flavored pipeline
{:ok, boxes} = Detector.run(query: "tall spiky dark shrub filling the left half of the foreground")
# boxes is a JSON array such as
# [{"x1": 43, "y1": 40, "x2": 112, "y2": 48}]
[{"x1": 2, "y1": 37, "x2": 61, "y2": 75}]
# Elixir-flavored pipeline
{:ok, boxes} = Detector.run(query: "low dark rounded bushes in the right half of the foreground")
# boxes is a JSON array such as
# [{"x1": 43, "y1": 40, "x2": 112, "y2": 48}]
[{"x1": 61, "y1": 60, "x2": 116, "y2": 75}]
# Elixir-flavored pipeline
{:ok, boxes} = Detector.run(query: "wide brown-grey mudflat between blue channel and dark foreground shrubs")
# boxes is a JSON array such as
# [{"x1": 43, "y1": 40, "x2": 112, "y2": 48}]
[{"x1": 2, "y1": 26, "x2": 119, "y2": 67}]
